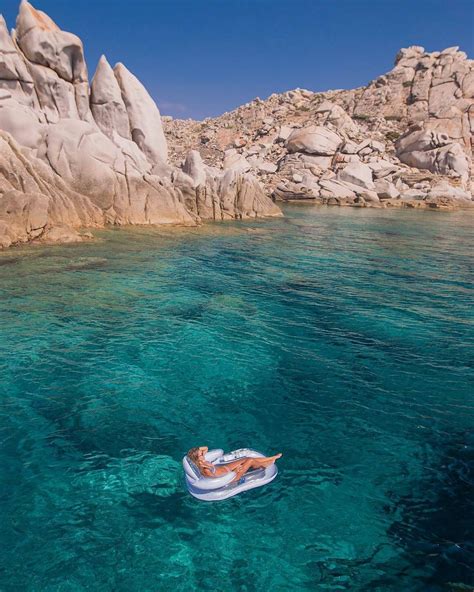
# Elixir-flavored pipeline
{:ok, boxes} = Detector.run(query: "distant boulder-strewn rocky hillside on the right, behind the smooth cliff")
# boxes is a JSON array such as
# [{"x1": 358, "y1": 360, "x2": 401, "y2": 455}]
[{"x1": 164, "y1": 47, "x2": 474, "y2": 209}]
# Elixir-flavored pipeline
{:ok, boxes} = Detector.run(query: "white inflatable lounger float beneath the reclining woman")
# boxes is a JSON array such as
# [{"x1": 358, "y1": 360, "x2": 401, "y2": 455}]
[{"x1": 183, "y1": 448, "x2": 278, "y2": 502}]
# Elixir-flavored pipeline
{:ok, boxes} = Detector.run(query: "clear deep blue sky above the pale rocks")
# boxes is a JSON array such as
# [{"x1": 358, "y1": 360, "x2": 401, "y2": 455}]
[{"x1": 0, "y1": 0, "x2": 474, "y2": 118}]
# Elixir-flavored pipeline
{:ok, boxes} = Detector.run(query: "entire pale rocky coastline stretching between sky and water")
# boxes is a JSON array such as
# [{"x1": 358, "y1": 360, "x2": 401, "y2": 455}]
[{"x1": 0, "y1": 0, "x2": 474, "y2": 248}]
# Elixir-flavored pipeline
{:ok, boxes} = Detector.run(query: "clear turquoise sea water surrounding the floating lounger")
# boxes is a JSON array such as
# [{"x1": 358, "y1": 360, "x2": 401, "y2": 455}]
[{"x1": 0, "y1": 207, "x2": 474, "y2": 592}]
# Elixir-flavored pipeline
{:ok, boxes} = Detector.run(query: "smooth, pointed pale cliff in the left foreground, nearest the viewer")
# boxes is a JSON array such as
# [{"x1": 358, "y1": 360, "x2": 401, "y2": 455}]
[{"x1": 0, "y1": 0, "x2": 280, "y2": 247}]
